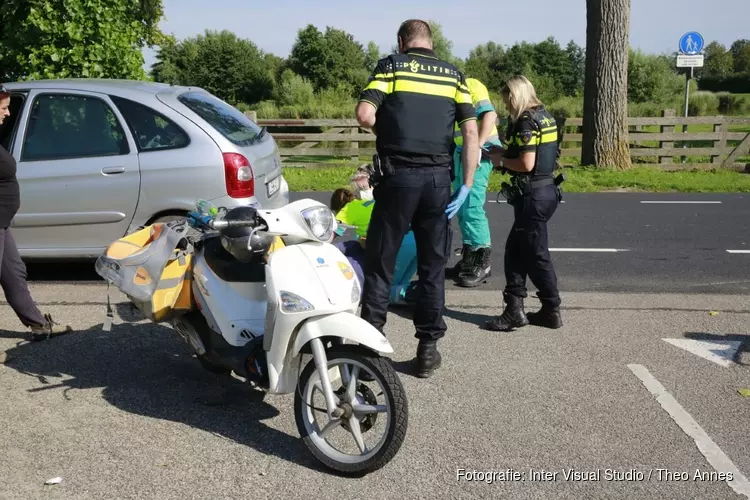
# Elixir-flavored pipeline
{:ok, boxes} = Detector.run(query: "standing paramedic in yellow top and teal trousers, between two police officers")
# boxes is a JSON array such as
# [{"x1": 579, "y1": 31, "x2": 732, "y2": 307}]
[{"x1": 453, "y1": 78, "x2": 502, "y2": 287}]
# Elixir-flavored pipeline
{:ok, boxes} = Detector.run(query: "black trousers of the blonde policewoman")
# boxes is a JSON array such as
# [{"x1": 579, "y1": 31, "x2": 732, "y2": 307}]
[{"x1": 505, "y1": 185, "x2": 560, "y2": 306}]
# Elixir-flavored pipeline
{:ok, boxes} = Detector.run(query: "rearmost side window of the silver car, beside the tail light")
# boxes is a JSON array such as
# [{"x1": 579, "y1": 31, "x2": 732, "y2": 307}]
[{"x1": 114, "y1": 96, "x2": 190, "y2": 152}]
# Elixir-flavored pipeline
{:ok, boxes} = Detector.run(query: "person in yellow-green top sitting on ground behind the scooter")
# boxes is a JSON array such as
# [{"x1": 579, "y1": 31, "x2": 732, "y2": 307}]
[{"x1": 331, "y1": 166, "x2": 418, "y2": 305}]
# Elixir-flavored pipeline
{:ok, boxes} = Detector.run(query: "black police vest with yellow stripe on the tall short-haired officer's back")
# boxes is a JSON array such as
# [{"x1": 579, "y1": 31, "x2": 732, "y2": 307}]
[{"x1": 376, "y1": 53, "x2": 468, "y2": 157}]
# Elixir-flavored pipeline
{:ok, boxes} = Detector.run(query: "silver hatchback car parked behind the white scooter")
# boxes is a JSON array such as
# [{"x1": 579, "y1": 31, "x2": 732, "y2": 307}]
[{"x1": 0, "y1": 79, "x2": 289, "y2": 260}]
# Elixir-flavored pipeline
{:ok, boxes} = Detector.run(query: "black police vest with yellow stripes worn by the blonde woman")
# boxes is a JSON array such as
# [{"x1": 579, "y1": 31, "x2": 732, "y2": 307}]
[{"x1": 507, "y1": 106, "x2": 559, "y2": 177}]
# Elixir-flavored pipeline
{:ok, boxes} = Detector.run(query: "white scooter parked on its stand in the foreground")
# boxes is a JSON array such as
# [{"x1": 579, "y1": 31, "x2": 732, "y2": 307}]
[{"x1": 172, "y1": 199, "x2": 408, "y2": 473}]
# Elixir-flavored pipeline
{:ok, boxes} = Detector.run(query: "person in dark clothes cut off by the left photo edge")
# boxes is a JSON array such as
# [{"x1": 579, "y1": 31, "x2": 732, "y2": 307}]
[{"x1": 0, "y1": 85, "x2": 72, "y2": 348}]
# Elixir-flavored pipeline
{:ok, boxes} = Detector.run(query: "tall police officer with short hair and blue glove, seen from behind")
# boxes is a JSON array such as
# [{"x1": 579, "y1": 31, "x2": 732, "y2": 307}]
[{"x1": 356, "y1": 19, "x2": 479, "y2": 378}]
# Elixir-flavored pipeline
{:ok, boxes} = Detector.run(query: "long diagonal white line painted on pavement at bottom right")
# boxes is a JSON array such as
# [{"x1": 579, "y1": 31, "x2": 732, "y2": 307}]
[{"x1": 628, "y1": 364, "x2": 750, "y2": 498}]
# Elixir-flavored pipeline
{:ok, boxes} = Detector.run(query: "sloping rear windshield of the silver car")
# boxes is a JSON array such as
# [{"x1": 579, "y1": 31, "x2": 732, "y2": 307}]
[{"x1": 177, "y1": 92, "x2": 263, "y2": 146}]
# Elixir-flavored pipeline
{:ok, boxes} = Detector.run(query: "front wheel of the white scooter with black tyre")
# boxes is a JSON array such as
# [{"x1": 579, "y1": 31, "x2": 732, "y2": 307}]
[{"x1": 294, "y1": 344, "x2": 409, "y2": 474}]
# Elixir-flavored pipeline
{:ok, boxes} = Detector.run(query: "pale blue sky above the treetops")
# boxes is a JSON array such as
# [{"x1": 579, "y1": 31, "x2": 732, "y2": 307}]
[{"x1": 144, "y1": 0, "x2": 750, "y2": 68}]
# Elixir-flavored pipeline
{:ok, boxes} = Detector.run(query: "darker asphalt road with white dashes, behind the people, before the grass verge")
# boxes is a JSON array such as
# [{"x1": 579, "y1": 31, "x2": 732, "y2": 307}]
[{"x1": 29, "y1": 192, "x2": 750, "y2": 294}]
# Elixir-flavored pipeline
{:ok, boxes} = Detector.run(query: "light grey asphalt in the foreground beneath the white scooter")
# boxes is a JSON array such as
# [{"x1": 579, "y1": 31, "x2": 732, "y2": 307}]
[{"x1": 0, "y1": 288, "x2": 750, "y2": 500}]
